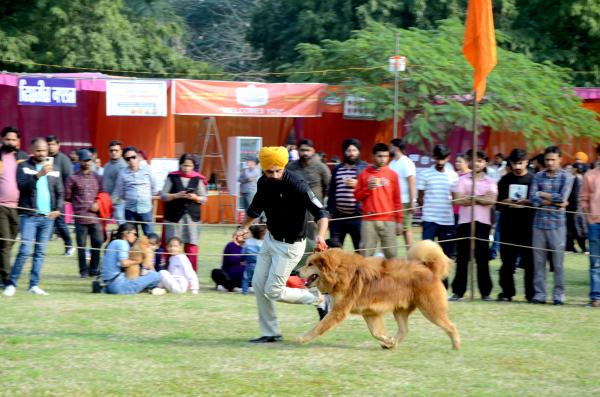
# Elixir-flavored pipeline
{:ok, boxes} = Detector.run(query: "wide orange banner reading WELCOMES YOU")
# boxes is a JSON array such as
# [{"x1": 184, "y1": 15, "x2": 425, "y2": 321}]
[{"x1": 175, "y1": 80, "x2": 326, "y2": 117}]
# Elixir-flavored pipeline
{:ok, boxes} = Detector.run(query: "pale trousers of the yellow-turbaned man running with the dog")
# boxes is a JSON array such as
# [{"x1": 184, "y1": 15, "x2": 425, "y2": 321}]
[{"x1": 252, "y1": 233, "x2": 319, "y2": 336}]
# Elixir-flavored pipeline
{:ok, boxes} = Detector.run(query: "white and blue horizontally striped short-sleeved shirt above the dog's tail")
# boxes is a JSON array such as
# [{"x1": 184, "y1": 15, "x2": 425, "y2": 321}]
[{"x1": 417, "y1": 166, "x2": 458, "y2": 225}]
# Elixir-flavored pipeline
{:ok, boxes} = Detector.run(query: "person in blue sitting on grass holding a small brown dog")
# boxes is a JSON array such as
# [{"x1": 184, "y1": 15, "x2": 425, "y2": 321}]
[{"x1": 102, "y1": 222, "x2": 165, "y2": 295}]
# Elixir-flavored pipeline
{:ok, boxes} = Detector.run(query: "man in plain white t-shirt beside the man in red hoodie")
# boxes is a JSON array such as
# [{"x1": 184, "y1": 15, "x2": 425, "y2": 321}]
[{"x1": 389, "y1": 138, "x2": 417, "y2": 249}]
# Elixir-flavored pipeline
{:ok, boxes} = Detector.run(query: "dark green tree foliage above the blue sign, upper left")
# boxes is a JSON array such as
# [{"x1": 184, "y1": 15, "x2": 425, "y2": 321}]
[{"x1": 0, "y1": 0, "x2": 215, "y2": 77}]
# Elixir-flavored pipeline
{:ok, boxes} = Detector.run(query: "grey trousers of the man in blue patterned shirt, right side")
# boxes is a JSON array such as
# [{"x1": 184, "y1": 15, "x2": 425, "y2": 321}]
[{"x1": 532, "y1": 226, "x2": 567, "y2": 302}]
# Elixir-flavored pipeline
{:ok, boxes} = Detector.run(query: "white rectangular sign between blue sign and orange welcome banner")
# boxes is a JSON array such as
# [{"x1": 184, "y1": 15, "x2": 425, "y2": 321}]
[{"x1": 106, "y1": 80, "x2": 167, "y2": 117}]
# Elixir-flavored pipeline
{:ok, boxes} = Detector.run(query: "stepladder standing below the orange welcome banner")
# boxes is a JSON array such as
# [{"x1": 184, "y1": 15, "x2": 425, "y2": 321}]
[{"x1": 194, "y1": 117, "x2": 237, "y2": 223}]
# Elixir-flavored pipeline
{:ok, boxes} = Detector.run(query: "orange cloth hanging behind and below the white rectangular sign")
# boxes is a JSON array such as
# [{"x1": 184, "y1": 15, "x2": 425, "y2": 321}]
[{"x1": 90, "y1": 88, "x2": 175, "y2": 163}]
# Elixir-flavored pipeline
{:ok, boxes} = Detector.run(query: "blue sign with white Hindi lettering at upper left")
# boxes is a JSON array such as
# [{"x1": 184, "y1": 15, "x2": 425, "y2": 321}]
[{"x1": 18, "y1": 77, "x2": 77, "y2": 107}]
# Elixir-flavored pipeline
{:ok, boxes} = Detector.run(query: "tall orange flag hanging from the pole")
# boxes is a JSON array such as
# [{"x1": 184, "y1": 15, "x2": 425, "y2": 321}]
[{"x1": 463, "y1": 0, "x2": 497, "y2": 102}]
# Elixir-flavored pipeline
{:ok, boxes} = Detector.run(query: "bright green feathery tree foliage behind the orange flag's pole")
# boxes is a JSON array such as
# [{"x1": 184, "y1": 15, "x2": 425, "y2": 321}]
[{"x1": 290, "y1": 19, "x2": 600, "y2": 147}]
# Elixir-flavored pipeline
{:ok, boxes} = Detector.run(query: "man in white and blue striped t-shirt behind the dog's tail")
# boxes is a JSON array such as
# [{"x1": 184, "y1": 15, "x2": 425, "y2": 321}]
[{"x1": 417, "y1": 144, "x2": 458, "y2": 284}]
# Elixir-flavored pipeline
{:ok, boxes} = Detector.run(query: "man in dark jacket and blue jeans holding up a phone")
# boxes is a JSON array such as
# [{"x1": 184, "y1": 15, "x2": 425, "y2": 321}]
[{"x1": 4, "y1": 138, "x2": 64, "y2": 296}]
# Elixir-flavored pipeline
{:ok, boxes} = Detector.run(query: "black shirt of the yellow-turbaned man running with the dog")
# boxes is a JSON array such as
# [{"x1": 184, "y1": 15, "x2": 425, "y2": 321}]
[{"x1": 246, "y1": 171, "x2": 329, "y2": 244}]
